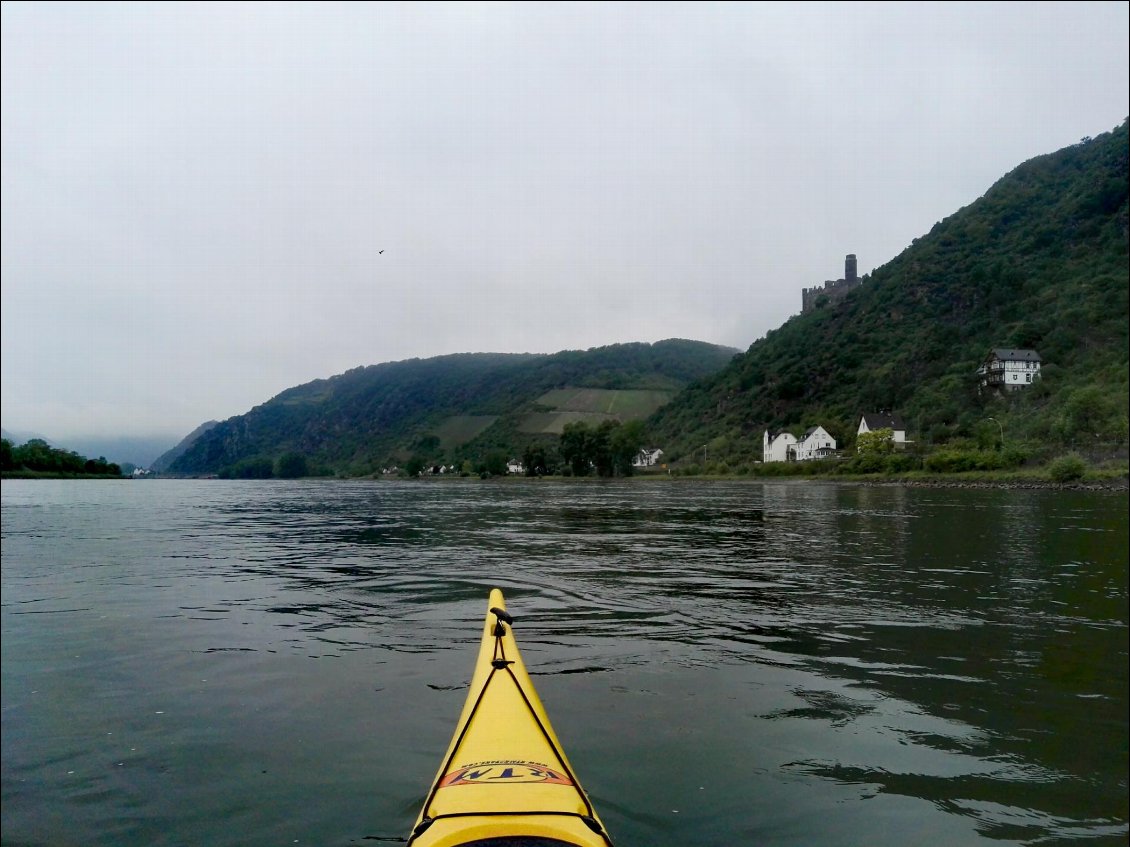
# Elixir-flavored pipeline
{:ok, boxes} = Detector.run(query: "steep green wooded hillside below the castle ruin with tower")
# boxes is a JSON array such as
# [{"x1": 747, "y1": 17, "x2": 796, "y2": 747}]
[{"x1": 649, "y1": 122, "x2": 1130, "y2": 464}]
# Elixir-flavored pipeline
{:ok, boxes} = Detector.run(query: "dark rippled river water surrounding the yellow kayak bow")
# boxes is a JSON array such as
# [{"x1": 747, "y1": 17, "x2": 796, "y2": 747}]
[{"x1": 0, "y1": 480, "x2": 1130, "y2": 847}]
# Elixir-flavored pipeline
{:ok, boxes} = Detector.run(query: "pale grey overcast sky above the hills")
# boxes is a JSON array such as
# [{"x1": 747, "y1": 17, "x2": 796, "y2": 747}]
[{"x1": 0, "y1": 1, "x2": 1130, "y2": 443}]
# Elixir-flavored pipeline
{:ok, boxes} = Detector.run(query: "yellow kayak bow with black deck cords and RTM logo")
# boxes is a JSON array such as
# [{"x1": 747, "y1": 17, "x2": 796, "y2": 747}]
[{"x1": 408, "y1": 588, "x2": 611, "y2": 847}]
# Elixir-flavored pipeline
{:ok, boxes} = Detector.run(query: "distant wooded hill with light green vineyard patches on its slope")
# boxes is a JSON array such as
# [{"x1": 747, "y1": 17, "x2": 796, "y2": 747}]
[{"x1": 168, "y1": 339, "x2": 738, "y2": 475}]
